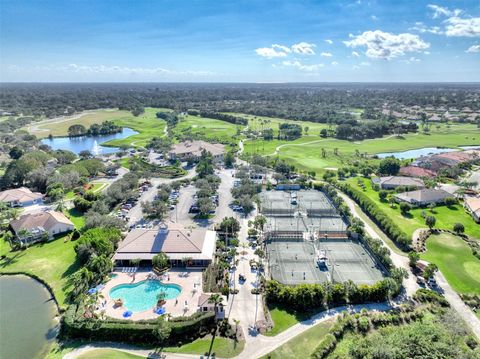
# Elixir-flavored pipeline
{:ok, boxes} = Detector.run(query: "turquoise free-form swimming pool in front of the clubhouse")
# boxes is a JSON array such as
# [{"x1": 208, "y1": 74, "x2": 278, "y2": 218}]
[{"x1": 109, "y1": 280, "x2": 182, "y2": 312}]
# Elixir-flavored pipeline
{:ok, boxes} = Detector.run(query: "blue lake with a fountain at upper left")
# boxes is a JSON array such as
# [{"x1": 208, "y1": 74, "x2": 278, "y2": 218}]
[{"x1": 42, "y1": 127, "x2": 138, "y2": 154}]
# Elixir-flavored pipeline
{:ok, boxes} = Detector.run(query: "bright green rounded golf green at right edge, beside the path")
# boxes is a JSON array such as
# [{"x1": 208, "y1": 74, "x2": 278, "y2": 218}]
[{"x1": 421, "y1": 233, "x2": 480, "y2": 294}]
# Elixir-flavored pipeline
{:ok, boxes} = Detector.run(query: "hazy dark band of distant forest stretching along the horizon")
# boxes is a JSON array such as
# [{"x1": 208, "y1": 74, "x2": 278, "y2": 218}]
[{"x1": 0, "y1": 83, "x2": 480, "y2": 123}]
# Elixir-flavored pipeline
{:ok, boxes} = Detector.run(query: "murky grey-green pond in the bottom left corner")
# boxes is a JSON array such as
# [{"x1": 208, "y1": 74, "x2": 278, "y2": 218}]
[{"x1": 0, "y1": 276, "x2": 59, "y2": 359}]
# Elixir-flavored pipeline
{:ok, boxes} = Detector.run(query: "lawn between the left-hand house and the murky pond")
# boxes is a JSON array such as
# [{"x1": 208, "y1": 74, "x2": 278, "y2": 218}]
[{"x1": 0, "y1": 237, "x2": 79, "y2": 306}]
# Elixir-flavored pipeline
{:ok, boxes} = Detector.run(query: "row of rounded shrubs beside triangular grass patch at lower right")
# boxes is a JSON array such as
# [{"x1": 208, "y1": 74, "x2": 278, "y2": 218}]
[{"x1": 311, "y1": 309, "x2": 424, "y2": 359}]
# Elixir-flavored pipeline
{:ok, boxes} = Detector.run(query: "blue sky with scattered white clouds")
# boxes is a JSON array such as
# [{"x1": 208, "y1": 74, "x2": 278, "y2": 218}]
[{"x1": 0, "y1": 0, "x2": 480, "y2": 82}]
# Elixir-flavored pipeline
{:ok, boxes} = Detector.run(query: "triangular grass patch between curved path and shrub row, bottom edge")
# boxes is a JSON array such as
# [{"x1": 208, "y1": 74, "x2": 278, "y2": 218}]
[{"x1": 262, "y1": 319, "x2": 335, "y2": 359}]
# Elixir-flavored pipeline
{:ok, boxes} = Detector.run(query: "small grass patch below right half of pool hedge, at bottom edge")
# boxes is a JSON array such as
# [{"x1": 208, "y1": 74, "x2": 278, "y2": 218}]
[{"x1": 163, "y1": 337, "x2": 244, "y2": 358}]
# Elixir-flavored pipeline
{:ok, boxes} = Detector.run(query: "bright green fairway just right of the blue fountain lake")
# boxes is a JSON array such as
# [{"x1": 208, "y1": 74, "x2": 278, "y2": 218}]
[{"x1": 102, "y1": 107, "x2": 170, "y2": 147}]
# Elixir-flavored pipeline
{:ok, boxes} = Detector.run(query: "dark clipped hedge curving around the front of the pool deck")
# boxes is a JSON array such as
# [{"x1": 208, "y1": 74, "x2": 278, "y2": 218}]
[{"x1": 61, "y1": 305, "x2": 215, "y2": 345}]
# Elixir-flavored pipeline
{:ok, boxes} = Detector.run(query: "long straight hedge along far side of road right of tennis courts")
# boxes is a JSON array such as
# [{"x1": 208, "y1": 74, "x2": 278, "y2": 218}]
[{"x1": 337, "y1": 183, "x2": 412, "y2": 250}]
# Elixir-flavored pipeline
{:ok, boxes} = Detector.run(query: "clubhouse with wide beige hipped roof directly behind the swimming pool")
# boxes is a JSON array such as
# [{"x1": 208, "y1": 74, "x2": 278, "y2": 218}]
[{"x1": 113, "y1": 226, "x2": 216, "y2": 267}]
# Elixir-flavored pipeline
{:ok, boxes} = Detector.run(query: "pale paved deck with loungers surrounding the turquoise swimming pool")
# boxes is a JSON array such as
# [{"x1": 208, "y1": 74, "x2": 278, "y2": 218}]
[{"x1": 97, "y1": 268, "x2": 202, "y2": 320}]
